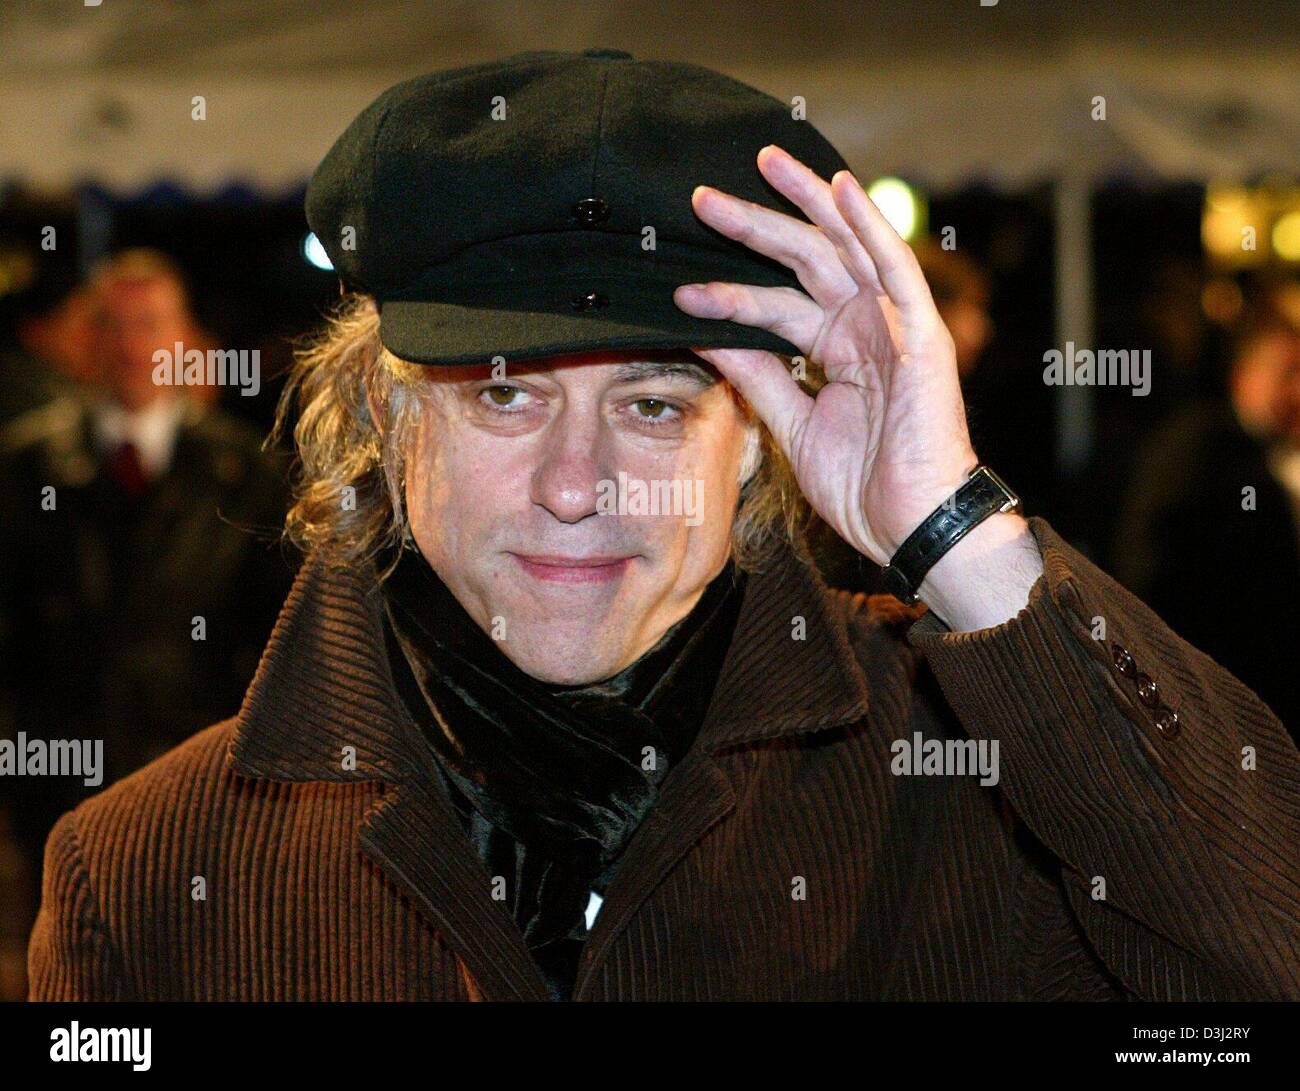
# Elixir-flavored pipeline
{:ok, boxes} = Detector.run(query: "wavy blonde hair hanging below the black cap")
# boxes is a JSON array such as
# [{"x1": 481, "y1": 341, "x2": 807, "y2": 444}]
[{"x1": 268, "y1": 293, "x2": 824, "y2": 575}]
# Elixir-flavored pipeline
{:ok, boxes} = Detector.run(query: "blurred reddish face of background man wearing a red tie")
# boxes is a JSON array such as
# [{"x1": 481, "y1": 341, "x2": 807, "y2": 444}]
[{"x1": 96, "y1": 277, "x2": 194, "y2": 410}]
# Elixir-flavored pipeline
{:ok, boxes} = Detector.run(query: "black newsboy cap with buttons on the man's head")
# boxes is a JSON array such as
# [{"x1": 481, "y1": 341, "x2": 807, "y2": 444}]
[{"x1": 307, "y1": 49, "x2": 846, "y2": 365}]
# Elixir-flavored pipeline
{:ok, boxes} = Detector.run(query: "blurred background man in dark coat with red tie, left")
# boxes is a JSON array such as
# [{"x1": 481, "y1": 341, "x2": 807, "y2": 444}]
[{"x1": 0, "y1": 251, "x2": 291, "y2": 995}]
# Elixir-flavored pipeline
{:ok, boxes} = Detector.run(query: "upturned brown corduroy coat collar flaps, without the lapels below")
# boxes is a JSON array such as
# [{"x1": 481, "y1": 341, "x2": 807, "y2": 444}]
[{"x1": 230, "y1": 540, "x2": 868, "y2": 783}]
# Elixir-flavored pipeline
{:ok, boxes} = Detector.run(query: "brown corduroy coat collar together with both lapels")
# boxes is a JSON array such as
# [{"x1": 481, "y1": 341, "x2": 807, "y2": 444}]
[{"x1": 228, "y1": 540, "x2": 867, "y2": 1000}]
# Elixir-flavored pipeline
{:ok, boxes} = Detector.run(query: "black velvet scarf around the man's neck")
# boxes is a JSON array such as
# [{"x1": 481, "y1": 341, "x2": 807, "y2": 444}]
[{"x1": 382, "y1": 550, "x2": 744, "y2": 1000}]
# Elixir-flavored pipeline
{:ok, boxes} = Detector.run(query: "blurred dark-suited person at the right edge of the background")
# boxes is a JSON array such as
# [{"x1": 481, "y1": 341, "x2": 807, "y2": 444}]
[{"x1": 1114, "y1": 283, "x2": 1300, "y2": 733}]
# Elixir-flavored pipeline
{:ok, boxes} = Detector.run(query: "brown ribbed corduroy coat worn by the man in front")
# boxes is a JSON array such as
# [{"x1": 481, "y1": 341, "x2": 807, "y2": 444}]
[{"x1": 22, "y1": 519, "x2": 1300, "y2": 1000}]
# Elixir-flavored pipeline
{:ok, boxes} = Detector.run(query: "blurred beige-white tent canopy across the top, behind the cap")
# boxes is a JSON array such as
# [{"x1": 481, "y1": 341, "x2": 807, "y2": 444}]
[{"x1": 0, "y1": 0, "x2": 1300, "y2": 192}]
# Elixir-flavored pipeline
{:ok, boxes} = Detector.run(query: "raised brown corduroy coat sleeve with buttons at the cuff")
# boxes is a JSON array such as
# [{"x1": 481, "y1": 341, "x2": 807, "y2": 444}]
[{"x1": 907, "y1": 518, "x2": 1300, "y2": 1000}]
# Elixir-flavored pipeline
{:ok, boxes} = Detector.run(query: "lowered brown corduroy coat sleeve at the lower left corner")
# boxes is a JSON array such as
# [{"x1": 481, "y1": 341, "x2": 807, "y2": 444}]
[{"x1": 27, "y1": 811, "x2": 124, "y2": 1000}]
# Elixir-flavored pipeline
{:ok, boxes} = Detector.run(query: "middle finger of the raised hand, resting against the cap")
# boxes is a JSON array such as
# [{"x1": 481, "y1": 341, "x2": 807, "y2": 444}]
[{"x1": 690, "y1": 186, "x2": 854, "y2": 300}]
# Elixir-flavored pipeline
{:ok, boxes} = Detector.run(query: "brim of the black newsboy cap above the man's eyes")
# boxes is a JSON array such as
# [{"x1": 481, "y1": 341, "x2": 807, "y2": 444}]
[{"x1": 380, "y1": 276, "x2": 800, "y2": 367}]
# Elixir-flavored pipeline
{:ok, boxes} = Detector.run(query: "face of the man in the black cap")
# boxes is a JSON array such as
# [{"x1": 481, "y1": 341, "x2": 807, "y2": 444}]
[{"x1": 406, "y1": 352, "x2": 746, "y2": 684}]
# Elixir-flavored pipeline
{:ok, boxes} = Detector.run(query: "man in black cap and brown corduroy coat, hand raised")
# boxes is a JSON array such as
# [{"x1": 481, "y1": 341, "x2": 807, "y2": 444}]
[{"x1": 31, "y1": 51, "x2": 1300, "y2": 1000}]
